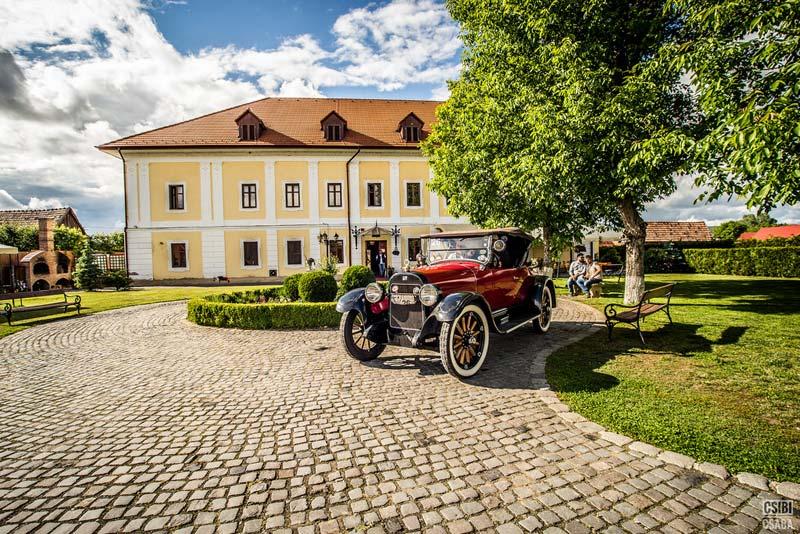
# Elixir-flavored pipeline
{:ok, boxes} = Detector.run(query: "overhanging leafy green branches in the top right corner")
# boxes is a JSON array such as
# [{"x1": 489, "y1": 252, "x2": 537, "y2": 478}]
[{"x1": 673, "y1": 0, "x2": 800, "y2": 211}]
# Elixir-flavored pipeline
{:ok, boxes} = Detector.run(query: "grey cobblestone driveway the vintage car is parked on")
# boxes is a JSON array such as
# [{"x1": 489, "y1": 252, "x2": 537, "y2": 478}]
[{"x1": 0, "y1": 301, "x2": 800, "y2": 534}]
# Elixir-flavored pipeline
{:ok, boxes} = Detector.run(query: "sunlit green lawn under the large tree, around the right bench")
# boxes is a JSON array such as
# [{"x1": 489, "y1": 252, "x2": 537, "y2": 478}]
[{"x1": 547, "y1": 275, "x2": 800, "y2": 482}]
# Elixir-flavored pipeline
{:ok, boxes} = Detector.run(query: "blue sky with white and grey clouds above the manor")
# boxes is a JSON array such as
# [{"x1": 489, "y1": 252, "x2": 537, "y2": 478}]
[{"x1": 0, "y1": 0, "x2": 800, "y2": 232}]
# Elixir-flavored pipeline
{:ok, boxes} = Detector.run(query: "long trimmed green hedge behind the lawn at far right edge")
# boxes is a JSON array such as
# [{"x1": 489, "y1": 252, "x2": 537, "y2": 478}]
[{"x1": 683, "y1": 247, "x2": 800, "y2": 278}]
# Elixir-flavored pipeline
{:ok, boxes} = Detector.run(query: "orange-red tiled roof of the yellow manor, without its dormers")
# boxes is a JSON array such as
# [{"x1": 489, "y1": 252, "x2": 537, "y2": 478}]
[{"x1": 98, "y1": 98, "x2": 440, "y2": 150}]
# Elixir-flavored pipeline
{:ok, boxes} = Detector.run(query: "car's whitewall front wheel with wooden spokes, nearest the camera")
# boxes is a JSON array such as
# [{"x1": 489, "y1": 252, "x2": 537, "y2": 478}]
[{"x1": 439, "y1": 304, "x2": 489, "y2": 378}]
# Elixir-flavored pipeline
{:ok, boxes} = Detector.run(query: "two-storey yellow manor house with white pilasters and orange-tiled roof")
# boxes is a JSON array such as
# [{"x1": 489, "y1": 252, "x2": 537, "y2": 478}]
[{"x1": 98, "y1": 98, "x2": 471, "y2": 280}]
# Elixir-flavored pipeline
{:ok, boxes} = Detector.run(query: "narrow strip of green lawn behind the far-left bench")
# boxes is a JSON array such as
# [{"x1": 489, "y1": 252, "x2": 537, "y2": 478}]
[{"x1": 0, "y1": 285, "x2": 278, "y2": 337}]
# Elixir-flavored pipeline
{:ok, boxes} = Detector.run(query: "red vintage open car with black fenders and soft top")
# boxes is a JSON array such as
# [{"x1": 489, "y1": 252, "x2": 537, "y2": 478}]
[{"x1": 336, "y1": 228, "x2": 556, "y2": 378}]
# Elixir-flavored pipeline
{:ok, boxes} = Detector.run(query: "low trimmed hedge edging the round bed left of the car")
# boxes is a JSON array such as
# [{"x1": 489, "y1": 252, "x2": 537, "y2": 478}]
[{"x1": 188, "y1": 298, "x2": 341, "y2": 330}]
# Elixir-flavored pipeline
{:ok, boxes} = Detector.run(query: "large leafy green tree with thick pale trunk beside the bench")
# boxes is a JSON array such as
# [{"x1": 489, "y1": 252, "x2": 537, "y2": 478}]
[{"x1": 424, "y1": 0, "x2": 695, "y2": 301}]
